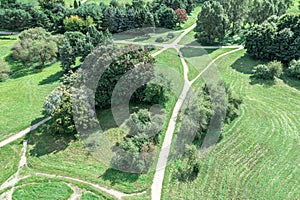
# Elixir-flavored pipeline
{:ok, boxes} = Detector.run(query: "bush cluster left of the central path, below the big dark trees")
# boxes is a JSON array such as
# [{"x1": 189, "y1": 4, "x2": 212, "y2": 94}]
[{"x1": 112, "y1": 109, "x2": 163, "y2": 173}]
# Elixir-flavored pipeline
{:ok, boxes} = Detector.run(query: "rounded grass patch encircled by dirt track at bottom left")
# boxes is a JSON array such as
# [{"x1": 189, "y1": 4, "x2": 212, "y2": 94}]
[{"x1": 13, "y1": 182, "x2": 73, "y2": 200}]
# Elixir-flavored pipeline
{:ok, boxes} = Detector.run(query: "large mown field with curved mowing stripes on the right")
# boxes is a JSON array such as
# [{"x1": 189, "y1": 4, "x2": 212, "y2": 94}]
[{"x1": 163, "y1": 51, "x2": 300, "y2": 199}]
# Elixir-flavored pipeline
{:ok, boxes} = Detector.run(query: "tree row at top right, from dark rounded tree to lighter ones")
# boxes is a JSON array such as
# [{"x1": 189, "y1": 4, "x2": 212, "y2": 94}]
[{"x1": 196, "y1": 0, "x2": 292, "y2": 43}]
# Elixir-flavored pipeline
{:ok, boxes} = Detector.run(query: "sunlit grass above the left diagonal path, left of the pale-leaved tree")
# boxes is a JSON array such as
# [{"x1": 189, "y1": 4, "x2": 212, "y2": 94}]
[{"x1": 0, "y1": 63, "x2": 60, "y2": 140}]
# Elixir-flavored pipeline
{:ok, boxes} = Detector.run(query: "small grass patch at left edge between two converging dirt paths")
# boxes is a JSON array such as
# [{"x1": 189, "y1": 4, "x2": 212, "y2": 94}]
[{"x1": 0, "y1": 141, "x2": 22, "y2": 185}]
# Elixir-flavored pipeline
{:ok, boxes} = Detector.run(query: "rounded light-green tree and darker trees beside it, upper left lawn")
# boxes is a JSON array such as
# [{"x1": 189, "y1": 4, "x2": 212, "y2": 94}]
[{"x1": 12, "y1": 26, "x2": 111, "y2": 69}]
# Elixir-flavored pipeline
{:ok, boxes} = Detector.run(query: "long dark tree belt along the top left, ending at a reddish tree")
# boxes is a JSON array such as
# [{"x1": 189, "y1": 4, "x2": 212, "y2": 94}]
[{"x1": 0, "y1": 0, "x2": 194, "y2": 33}]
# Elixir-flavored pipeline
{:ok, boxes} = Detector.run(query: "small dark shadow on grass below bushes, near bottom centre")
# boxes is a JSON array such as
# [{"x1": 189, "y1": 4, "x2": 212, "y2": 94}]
[{"x1": 99, "y1": 168, "x2": 140, "y2": 185}]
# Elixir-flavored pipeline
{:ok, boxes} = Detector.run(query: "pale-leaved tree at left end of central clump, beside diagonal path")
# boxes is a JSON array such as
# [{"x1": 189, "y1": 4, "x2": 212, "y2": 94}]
[{"x1": 44, "y1": 73, "x2": 98, "y2": 136}]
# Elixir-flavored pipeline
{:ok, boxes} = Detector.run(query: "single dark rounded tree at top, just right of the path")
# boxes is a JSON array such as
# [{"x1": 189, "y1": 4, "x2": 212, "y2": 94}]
[{"x1": 195, "y1": 1, "x2": 228, "y2": 43}]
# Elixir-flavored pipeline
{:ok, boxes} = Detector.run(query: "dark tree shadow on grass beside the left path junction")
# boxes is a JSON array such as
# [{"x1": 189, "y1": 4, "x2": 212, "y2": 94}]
[{"x1": 25, "y1": 124, "x2": 75, "y2": 157}]
